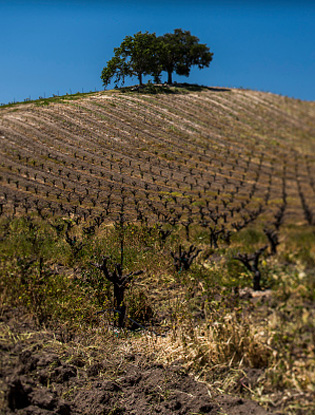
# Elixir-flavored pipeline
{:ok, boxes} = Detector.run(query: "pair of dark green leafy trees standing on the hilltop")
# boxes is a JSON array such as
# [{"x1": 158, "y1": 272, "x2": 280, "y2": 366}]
[{"x1": 101, "y1": 29, "x2": 213, "y2": 87}]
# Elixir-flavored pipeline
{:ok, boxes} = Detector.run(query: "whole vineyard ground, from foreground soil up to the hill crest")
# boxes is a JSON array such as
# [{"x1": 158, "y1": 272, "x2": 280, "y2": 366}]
[{"x1": 0, "y1": 84, "x2": 315, "y2": 415}]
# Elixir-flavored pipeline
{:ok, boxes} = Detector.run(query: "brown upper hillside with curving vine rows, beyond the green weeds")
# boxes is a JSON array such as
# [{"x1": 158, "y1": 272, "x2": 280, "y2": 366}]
[{"x1": 0, "y1": 87, "x2": 315, "y2": 228}]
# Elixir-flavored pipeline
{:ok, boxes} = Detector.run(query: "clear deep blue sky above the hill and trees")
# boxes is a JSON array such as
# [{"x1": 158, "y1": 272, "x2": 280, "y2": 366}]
[{"x1": 0, "y1": 0, "x2": 315, "y2": 103}]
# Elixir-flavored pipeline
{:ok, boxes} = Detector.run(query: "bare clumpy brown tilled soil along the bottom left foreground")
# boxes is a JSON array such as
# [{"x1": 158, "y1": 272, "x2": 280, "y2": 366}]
[{"x1": 0, "y1": 309, "x2": 269, "y2": 415}]
